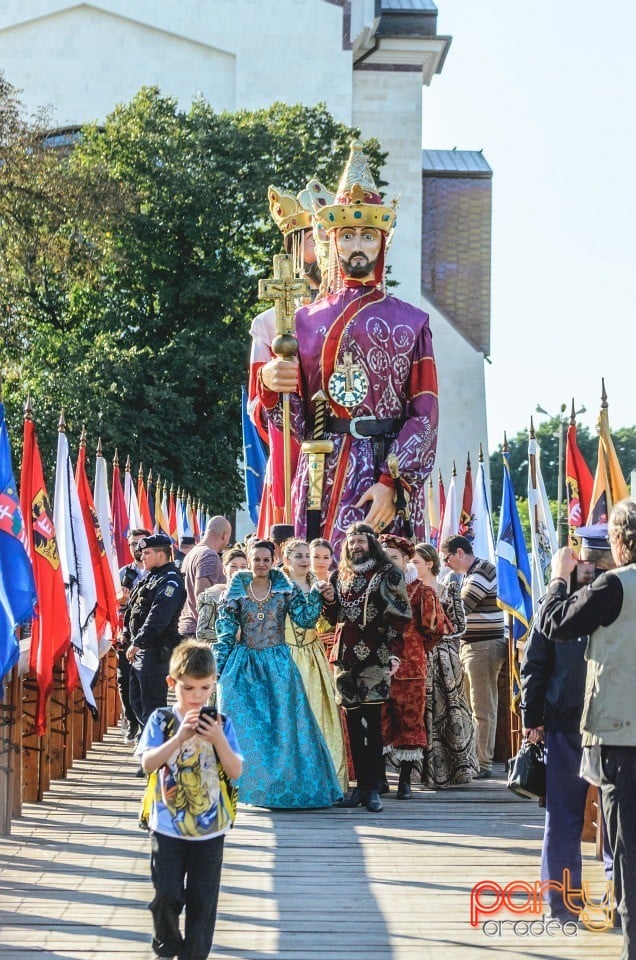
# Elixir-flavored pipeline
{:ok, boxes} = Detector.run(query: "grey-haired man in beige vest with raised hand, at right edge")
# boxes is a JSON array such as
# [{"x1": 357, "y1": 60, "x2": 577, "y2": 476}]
[{"x1": 539, "y1": 499, "x2": 636, "y2": 960}]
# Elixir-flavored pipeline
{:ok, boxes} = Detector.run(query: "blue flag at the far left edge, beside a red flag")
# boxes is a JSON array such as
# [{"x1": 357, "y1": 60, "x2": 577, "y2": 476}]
[{"x1": 0, "y1": 403, "x2": 37, "y2": 678}]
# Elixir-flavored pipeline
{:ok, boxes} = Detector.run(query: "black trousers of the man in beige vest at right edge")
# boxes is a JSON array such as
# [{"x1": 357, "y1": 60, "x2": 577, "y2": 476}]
[{"x1": 601, "y1": 746, "x2": 636, "y2": 960}]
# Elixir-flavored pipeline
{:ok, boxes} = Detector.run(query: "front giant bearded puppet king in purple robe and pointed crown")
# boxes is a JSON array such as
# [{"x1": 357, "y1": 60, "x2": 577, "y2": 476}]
[{"x1": 257, "y1": 144, "x2": 438, "y2": 556}]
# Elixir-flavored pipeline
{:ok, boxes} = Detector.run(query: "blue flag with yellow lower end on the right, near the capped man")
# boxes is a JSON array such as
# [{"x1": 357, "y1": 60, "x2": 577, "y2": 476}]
[{"x1": 495, "y1": 453, "x2": 532, "y2": 712}]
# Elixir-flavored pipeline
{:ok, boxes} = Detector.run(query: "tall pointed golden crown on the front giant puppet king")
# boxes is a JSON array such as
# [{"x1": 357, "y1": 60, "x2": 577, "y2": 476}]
[{"x1": 314, "y1": 143, "x2": 397, "y2": 233}]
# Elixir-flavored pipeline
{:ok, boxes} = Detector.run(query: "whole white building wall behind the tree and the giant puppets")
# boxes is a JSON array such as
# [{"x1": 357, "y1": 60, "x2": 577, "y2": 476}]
[{"x1": 0, "y1": 0, "x2": 488, "y2": 516}]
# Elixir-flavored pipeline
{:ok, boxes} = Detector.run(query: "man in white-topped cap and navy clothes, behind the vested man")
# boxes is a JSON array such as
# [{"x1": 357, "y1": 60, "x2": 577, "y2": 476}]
[{"x1": 521, "y1": 523, "x2": 616, "y2": 923}]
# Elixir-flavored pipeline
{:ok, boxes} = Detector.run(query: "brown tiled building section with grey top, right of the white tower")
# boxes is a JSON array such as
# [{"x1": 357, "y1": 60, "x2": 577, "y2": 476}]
[{"x1": 422, "y1": 150, "x2": 492, "y2": 356}]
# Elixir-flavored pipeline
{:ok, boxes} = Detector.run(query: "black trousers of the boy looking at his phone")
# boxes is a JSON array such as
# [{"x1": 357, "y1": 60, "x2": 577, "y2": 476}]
[{"x1": 148, "y1": 833, "x2": 225, "y2": 960}]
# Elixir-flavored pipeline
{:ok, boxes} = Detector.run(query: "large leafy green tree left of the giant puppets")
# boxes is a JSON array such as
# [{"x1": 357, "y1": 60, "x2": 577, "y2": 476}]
[{"x1": 0, "y1": 88, "x2": 384, "y2": 512}]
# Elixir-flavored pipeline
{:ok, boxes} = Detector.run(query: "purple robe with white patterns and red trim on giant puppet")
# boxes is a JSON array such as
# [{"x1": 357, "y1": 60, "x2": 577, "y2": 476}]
[{"x1": 260, "y1": 287, "x2": 438, "y2": 556}]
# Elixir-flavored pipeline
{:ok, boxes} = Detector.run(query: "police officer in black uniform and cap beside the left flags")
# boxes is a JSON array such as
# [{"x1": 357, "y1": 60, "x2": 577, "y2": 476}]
[{"x1": 124, "y1": 533, "x2": 186, "y2": 744}]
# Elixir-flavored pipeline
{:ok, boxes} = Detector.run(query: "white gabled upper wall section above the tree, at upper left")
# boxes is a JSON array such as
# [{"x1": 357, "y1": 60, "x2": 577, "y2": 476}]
[{"x1": 0, "y1": 0, "x2": 351, "y2": 126}]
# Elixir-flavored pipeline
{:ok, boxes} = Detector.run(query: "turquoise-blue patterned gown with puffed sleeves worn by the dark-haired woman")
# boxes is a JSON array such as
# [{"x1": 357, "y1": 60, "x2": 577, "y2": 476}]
[{"x1": 214, "y1": 570, "x2": 342, "y2": 809}]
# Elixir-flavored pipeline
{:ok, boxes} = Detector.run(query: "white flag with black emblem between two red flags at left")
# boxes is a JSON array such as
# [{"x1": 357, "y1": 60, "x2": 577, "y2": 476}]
[{"x1": 53, "y1": 431, "x2": 99, "y2": 712}]
